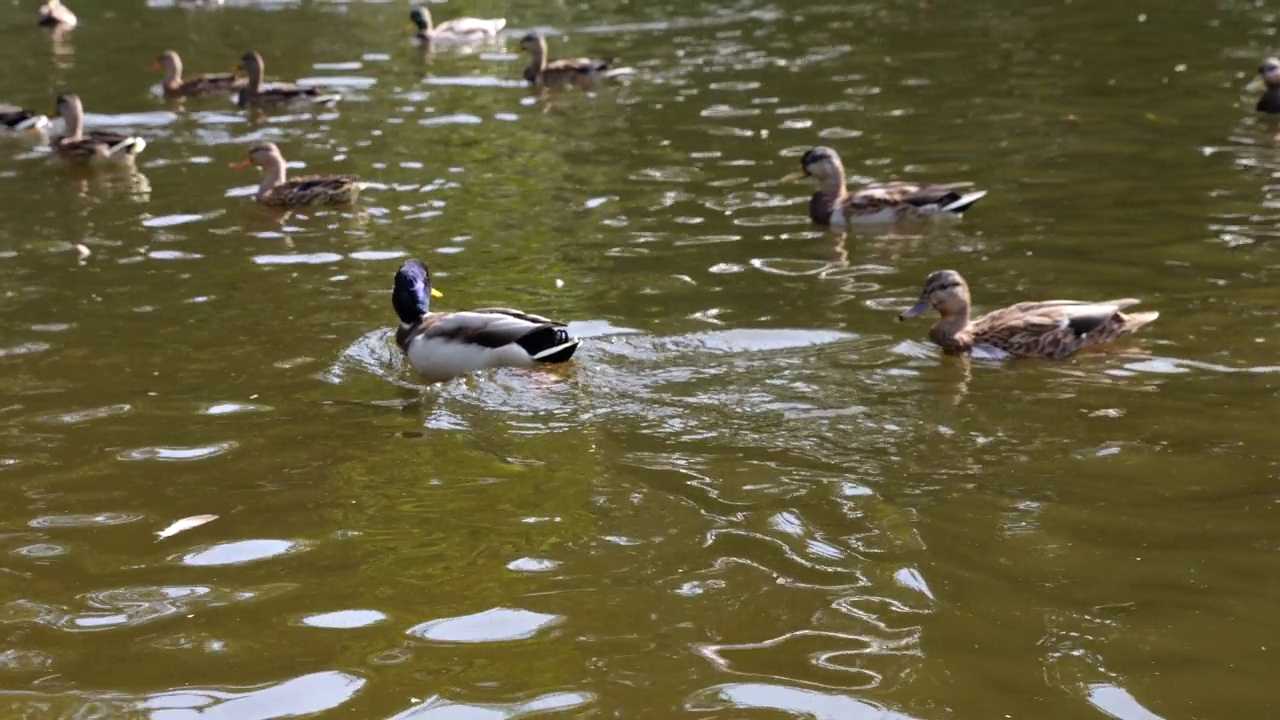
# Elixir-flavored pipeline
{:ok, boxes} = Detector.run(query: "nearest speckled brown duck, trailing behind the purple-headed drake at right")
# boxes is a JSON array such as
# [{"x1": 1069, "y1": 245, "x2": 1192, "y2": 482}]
[{"x1": 897, "y1": 270, "x2": 1160, "y2": 360}]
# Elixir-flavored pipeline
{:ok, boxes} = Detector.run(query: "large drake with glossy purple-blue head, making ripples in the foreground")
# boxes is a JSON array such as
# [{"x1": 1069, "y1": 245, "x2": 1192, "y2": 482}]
[{"x1": 392, "y1": 259, "x2": 582, "y2": 382}]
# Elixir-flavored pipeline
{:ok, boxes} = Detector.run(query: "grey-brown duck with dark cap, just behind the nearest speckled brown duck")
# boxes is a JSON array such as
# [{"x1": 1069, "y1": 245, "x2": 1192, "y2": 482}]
[{"x1": 782, "y1": 147, "x2": 987, "y2": 228}]
